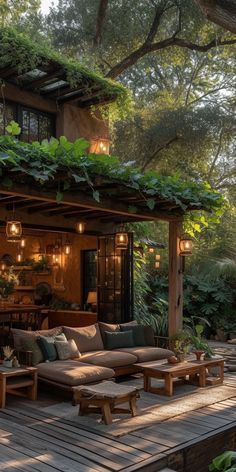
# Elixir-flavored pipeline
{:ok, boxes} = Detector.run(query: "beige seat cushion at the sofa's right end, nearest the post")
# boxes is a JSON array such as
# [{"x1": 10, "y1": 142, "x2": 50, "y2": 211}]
[{"x1": 119, "y1": 346, "x2": 174, "y2": 362}]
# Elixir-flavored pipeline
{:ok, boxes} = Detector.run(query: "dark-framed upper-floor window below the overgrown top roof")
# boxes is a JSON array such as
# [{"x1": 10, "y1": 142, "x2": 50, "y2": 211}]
[{"x1": 0, "y1": 102, "x2": 55, "y2": 143}]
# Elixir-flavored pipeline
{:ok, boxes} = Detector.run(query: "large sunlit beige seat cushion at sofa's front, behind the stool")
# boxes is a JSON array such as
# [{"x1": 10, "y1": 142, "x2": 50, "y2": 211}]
[{"x1": 37, "y1": 360, "x2": 115, "y2": 387}]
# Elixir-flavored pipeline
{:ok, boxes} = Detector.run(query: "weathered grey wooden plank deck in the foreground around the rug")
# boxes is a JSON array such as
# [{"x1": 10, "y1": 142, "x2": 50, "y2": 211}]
[{"x1": 0, "y1": 375, "x2": 236, "y2": 472}]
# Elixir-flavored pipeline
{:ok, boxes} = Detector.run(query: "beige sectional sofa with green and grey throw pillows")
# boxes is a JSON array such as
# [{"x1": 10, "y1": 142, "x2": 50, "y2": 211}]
[{"x1": 12, "y1": 322, "x2": 173, "y2": 391}]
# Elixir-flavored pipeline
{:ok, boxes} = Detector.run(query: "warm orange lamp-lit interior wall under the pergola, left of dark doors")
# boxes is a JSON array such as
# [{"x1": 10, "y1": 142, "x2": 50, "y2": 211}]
[{"x1": 0, "y1": 232, "x2": 97, "y2": 304}]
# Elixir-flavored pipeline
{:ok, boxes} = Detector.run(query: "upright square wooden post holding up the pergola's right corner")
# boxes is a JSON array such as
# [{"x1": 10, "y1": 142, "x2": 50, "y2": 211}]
[{"x1": 168, "y1": 219, "x2": 183, "y2": 336}]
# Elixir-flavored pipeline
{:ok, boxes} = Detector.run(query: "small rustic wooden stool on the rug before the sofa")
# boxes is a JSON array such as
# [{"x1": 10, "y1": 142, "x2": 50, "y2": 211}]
[{"x1": 73, "y1": 381, "x2": 139, "y2": 424}]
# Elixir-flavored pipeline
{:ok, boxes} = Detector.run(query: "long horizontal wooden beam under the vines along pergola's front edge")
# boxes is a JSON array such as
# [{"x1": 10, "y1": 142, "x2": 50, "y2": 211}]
[{"x1": 0, "y1": 184, "x2": 173, "y2": 221}]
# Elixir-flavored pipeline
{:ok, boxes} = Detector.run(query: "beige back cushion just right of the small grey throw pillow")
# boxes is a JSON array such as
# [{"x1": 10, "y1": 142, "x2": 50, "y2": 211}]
[{"x1": 63, "y1": 323, "x2": 104, "y2": 352}]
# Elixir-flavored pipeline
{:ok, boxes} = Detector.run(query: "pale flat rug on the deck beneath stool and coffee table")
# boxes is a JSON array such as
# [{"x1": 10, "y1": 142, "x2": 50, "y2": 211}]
[{"x1": 42, "y1": 375, "x2": 236, "y2": 437}]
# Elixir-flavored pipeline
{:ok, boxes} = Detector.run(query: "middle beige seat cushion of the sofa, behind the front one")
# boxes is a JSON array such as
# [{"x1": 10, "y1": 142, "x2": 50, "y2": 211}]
[{"x1": 80, "y1": 350, "x2": 137, "y2": 367}]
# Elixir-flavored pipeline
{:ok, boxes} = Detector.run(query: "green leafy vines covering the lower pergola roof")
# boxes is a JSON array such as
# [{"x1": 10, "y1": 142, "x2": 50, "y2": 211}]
[{"x1": 0, "y1": 122, "x2": 223, "y2": 218}]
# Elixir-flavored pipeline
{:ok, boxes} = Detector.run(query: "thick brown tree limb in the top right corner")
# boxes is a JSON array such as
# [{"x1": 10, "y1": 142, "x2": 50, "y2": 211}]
[{"x1": 195, "y1": 0, "x2": 236, "y2": 33}]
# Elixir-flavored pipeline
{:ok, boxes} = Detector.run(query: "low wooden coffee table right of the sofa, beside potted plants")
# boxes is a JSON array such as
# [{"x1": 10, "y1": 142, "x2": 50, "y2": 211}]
[{"x1": 142, "y1": 359, "x2": 224, "y2": 396}]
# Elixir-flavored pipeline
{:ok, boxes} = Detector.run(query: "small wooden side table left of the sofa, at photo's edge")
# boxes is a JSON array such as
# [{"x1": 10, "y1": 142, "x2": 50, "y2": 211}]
[{"x1": 0, "y1": 365, "x2": 37, "y2": 408}]
